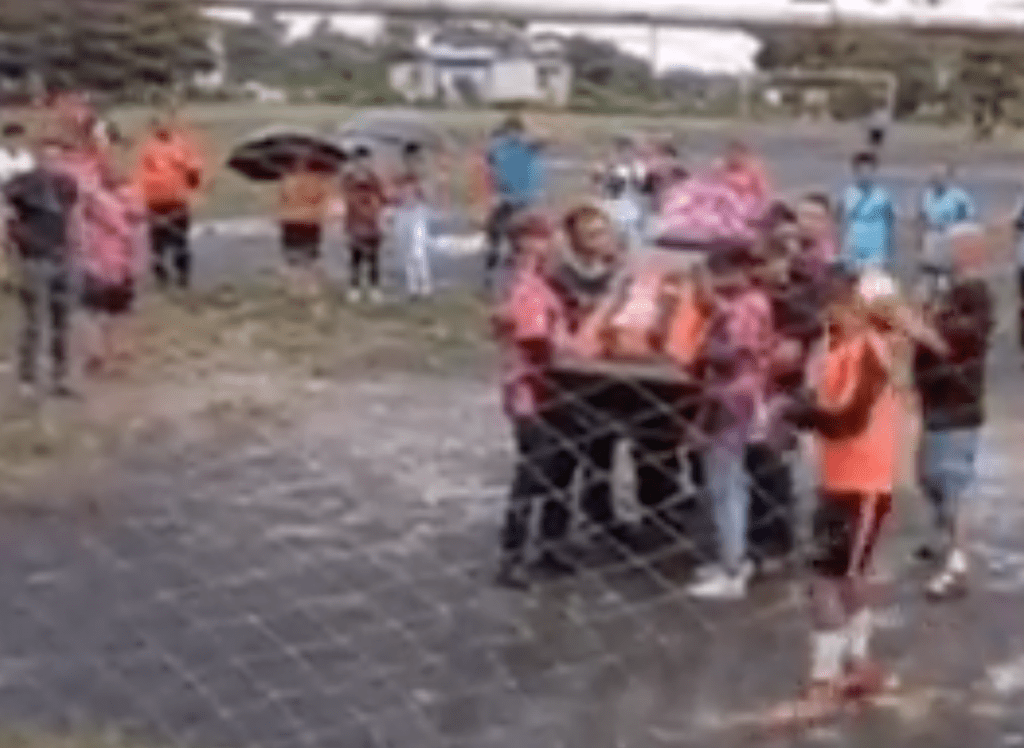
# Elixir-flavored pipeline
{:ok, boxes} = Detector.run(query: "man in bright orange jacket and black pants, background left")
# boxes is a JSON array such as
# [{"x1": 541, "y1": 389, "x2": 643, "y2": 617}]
[{"x1": 136, "y1": 115, "x2": 204, "y2": 288}]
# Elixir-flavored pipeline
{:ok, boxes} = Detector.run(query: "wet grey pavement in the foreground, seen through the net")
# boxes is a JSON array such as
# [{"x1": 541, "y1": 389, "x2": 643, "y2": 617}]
[{"x1": 0, "y1": 360, "x2": 1024, "y2": 748}]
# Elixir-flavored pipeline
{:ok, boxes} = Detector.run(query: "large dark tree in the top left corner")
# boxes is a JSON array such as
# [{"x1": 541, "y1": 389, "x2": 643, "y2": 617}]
[{"x1": 0, "y1": 0, "x2": 210, "y2": 91}]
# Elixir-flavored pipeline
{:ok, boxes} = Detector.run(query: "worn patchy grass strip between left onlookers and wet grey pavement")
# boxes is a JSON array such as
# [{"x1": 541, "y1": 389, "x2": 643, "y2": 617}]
[{"x1": 0, "y1": 281, "x2": 493, "y2": 497}]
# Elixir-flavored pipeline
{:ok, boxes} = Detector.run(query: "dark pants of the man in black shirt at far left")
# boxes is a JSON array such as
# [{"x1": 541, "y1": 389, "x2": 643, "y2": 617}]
[{"x1": 18, "y1": 258, "x2": 73, "y2": 384}]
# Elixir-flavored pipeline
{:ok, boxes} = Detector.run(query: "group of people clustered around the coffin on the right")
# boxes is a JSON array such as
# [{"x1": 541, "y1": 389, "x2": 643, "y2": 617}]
[{"x1": 495, "y1": 128, "x2": 994, "y2": 719}]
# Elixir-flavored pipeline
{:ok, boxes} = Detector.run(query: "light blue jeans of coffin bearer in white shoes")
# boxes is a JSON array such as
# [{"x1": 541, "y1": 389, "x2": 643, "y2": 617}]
[{"x1": 705, "y1": 444, "x2": 751, "y2": 572}]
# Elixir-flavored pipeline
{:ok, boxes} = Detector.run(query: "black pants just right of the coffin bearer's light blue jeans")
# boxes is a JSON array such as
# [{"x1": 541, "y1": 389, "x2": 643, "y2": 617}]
[{"x1": 745, "y1": 444, "x2": 796, "y2": 557}]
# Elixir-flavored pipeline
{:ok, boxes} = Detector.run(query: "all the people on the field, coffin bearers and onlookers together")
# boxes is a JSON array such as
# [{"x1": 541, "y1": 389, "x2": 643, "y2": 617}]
[{"x1": 0, "y1": 97, "x2": 1007, "y2": 713}]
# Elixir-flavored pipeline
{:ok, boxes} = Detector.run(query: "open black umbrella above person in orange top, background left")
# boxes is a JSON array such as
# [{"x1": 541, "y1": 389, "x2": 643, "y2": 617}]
[{"x1": 227, "y1": 126, "x2": 347, "y2": 181}]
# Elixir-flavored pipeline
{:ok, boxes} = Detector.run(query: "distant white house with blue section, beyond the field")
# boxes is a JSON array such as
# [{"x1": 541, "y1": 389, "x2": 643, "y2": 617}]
[{"x1": 388, "y1": 28, "x2": 572, "y2": 107}]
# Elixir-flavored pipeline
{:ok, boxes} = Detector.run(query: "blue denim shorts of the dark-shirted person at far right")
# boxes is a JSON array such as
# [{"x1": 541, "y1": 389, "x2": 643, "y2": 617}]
[{"x1": 920, "y1": 428, "x2": 980, "y2": 528}]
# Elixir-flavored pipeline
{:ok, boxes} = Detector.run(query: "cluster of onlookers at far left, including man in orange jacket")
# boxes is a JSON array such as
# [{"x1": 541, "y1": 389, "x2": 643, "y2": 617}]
[{"x1": 0, "y1": 95, "x2": 205, "y2": 397}]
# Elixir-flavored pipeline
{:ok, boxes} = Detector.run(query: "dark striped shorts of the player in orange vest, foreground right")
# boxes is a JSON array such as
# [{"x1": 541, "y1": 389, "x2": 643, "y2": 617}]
[{"x1": 810, "y1": 493, "x2": 892, "y2": 577}]
